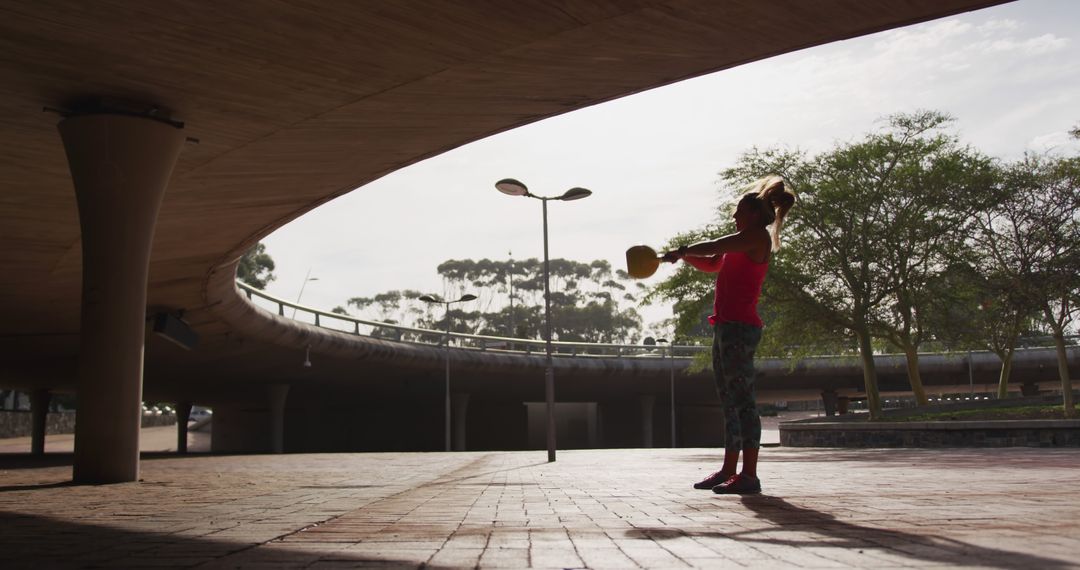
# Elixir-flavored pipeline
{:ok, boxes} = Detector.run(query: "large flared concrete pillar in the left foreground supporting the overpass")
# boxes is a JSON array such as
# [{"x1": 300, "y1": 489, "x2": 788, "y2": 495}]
[{"x1": 58, "y1": 113, "x2": 185, "y2": 483}]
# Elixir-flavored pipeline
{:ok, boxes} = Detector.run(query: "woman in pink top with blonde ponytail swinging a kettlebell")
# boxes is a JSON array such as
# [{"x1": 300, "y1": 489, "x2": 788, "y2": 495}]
[{"x1": 663, "y1": 176, "x2": 795, "y2": 494}]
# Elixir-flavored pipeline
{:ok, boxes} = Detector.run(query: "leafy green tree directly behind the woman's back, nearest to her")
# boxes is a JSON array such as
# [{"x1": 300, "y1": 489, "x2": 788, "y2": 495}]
[{"x1": 721, "y1": 145, "x2": 892, "y2": 419}]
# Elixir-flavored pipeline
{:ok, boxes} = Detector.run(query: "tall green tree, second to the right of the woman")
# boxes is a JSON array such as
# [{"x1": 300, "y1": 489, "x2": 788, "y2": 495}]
[{"x1": 851, "y1": 111, "x2": 994, "y2": 405}]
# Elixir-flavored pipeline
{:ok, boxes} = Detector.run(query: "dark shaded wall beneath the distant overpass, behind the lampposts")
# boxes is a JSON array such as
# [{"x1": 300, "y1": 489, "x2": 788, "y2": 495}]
[{"x1": 212, "y1": 391, "x2": 723, "y2": 453}]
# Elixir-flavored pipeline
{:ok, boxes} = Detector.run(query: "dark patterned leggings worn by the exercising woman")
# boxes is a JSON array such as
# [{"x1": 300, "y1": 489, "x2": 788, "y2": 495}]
[{"x1": 713, "y1": 323, "x2": 761, "y2": 450}]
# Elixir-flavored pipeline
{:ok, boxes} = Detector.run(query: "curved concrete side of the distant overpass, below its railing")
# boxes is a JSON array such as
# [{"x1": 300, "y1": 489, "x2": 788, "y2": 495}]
[{"x1": 206, "y1": 282, "x2": 1080, "y2": 403}]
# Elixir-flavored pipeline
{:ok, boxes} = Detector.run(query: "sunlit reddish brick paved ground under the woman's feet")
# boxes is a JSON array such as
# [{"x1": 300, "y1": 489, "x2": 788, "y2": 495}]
[{"x1": 0, "y1": 448, "x2": 1080, "y2": 569}]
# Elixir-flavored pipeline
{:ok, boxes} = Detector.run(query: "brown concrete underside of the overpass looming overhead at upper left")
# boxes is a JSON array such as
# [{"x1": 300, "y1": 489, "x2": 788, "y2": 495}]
[{"x1": 0, "y1": 0, "x2": 1001, "y2": 401}]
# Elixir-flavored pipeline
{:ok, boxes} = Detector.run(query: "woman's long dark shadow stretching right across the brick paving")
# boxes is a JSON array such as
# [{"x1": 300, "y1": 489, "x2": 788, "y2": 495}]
[{"x1": 626, "y1": 494, "x2": 1075, "y2": 569}]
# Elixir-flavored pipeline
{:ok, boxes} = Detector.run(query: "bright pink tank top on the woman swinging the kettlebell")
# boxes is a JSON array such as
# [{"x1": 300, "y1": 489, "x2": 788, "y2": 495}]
[{"x1": 708, "y1": 252, "x2": 769, "y2": 327}]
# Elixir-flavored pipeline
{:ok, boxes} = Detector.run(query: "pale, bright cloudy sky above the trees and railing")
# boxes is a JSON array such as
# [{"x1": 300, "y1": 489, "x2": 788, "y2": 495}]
[{"x1": 264, "y1": 0, "x2": 1080, "y2": 335}]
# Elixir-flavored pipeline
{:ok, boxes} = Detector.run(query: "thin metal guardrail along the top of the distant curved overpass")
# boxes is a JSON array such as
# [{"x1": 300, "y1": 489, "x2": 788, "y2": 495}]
[{"x1": 237, "y1": 280, "x2": 1080, "y2": 358}]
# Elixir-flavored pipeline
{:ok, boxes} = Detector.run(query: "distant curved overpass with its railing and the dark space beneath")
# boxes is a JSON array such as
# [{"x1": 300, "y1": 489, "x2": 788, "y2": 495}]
[{"x1": 192, "y1": 283, "x2": 1080, "y2": 451}]
